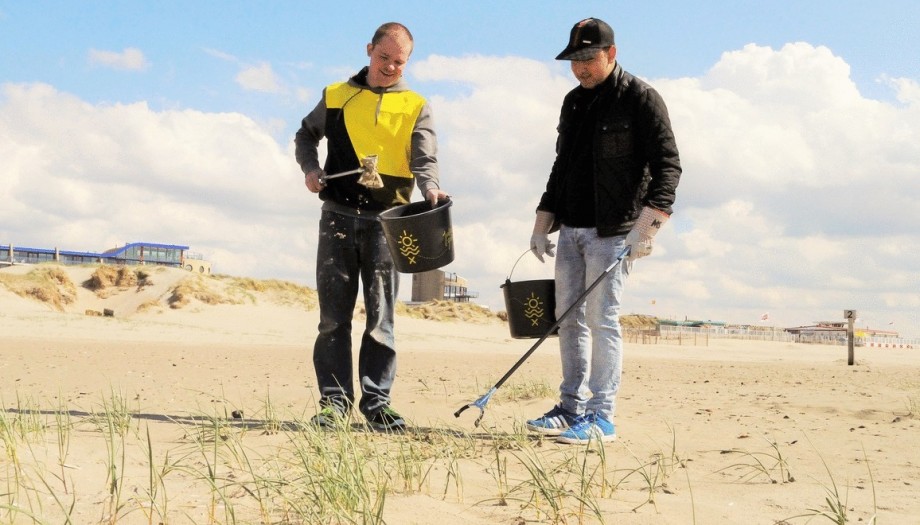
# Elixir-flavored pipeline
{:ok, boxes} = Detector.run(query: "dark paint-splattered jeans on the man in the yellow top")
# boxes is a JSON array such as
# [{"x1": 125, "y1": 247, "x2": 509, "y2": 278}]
[{"x1": 313, "y1": 210, "x2": 399, "y2": 416}]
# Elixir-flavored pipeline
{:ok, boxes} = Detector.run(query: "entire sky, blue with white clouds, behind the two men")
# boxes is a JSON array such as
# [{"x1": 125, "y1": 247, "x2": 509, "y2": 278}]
[{"x1": 0, "y1": 0, "x2": 920, "y2": 337}]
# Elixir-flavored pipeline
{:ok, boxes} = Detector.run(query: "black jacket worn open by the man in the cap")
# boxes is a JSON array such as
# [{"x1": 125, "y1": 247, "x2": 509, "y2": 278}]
[{"x1": 537, "y1": 64, "x2": 681, "y2": 236}]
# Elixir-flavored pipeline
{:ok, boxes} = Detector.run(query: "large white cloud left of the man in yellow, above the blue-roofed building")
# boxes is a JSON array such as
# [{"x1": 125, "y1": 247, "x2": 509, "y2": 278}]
[{"x1": 0, "y1": 80, "x2": 315, "y2": 280}]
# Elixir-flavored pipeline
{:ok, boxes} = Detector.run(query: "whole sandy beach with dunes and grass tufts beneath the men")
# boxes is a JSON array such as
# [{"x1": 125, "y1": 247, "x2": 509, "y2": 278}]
[{"x1": 0, "y1": 266, "x2": 920, "y2": 525}]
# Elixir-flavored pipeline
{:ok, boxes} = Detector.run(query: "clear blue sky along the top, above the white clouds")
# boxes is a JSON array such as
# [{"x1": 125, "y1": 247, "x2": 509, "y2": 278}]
[{"x1": 0, "y1": 0, "x2": 920, "y2": 120}]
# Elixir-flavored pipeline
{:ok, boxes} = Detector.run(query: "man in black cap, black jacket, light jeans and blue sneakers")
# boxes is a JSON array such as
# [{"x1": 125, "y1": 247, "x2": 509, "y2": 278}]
[{"x1": 527, "y1": 18, "x2": 681, "y2": 443}]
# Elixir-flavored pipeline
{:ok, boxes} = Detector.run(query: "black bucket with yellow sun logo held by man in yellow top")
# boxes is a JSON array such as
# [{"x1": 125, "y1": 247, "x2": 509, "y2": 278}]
[{"x1": 380, "y1": 195, "x2": 454, "y2": 273}]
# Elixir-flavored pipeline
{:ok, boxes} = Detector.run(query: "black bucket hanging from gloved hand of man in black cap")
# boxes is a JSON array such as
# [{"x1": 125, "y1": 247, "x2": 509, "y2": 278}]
[{"x1": 501, "y1": 250, "x2": 559, "y2": 339}]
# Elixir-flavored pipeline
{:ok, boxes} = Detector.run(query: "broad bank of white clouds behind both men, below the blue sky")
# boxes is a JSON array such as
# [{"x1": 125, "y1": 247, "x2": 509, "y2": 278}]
[{"x1": 0, "y1": 43, "x2": 920, "y2": 334}]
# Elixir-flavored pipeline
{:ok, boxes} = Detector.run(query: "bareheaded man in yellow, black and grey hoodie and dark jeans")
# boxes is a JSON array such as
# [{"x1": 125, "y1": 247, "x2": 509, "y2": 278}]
[{"x1": 294, "y1": 22, "x2": 447, "y2": 431}]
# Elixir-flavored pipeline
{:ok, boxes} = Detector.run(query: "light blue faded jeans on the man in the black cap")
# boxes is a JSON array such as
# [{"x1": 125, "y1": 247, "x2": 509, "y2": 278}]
[{"x1": 556, "y1": 226, "x2": 628, "y2": 421}]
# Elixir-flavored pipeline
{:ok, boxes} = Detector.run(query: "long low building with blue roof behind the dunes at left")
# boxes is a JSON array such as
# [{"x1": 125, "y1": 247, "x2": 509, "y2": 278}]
[{"x1": 0, "y1": 242, "x2": 211, "y2": 274}]
